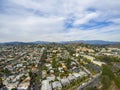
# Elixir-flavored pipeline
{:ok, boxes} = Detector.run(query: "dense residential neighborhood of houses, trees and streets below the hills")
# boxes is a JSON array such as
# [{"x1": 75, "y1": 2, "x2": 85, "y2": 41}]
[{"x1": 0, "y1": 43, "x2": 120, "y2": 90}]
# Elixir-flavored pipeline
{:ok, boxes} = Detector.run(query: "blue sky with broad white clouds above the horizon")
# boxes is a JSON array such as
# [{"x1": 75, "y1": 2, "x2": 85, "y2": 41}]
[{"x1": 0, "y1": 0, "x2": 120, "y2": 42}]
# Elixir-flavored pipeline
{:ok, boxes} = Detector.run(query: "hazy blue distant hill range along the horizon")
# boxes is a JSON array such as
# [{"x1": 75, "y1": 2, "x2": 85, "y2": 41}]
[{"x1": 0, "y1": 40, "x2": 120, "y2": 45}]
